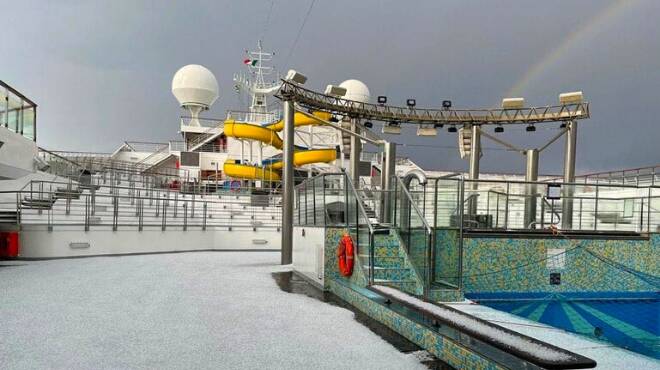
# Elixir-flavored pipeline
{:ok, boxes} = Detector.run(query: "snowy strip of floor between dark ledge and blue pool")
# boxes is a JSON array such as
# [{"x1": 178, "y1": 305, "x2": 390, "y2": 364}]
[{"x1": 447, "y1": 303, "x2": 660, "y2": 370}]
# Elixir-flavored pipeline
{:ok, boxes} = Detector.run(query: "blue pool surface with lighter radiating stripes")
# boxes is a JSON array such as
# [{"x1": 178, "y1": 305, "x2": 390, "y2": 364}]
[{"x1": 466, "y1": 292, "x2": 660, "y2": 359}]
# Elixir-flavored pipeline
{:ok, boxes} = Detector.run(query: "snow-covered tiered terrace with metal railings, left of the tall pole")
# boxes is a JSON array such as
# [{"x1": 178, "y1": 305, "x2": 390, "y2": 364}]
[{"x1": 0, "y1": 181, "x2": 281, "y2": 231}]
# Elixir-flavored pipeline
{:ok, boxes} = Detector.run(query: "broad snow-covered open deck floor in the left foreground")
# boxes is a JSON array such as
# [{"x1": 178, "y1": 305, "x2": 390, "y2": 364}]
[{"x1": 0, "y1": 252, "x2": 425, "y2": 370}]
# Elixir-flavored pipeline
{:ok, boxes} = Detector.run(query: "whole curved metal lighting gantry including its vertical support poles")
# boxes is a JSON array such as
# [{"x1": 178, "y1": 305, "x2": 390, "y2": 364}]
[{"x1": 275, "y1": 80, "x2": 590, "y2": 264}]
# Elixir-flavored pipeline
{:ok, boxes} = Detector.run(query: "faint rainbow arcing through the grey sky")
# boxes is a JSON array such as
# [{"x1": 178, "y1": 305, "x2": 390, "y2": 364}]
[{"x1": 505, "y1": 0, "x2": 637, "y2": 97}]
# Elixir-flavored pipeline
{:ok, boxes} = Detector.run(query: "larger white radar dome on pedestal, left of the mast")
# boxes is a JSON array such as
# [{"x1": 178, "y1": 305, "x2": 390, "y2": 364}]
[{"x1": 172, "y1": 64, "x2": 219, "y2": 126}]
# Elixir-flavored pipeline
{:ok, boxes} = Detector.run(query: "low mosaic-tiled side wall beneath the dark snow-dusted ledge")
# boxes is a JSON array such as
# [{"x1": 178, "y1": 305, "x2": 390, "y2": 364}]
[{"x1": 328, "y1": 280, "x2": 504, "y2": 370}]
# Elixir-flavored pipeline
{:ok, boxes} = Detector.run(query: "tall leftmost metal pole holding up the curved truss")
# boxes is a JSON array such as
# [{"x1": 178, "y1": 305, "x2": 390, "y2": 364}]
[{"x1": 281, "y1": 100, "x2": 295, "y2": 265}]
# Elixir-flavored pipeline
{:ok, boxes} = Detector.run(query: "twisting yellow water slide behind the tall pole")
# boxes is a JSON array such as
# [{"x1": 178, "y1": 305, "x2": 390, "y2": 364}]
[{"x1": 223, "y1": 112, "x2": 337, "y2": 181}]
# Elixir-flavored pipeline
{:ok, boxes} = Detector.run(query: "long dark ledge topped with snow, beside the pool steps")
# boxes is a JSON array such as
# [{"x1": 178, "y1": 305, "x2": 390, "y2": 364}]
[{"x1": 370, "y1": 285, "x2": 596, "y2": 369}]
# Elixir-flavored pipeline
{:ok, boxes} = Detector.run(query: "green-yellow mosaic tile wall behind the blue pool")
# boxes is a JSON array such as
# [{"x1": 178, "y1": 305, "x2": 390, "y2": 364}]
[{"x1": 463, "y1": 234, "x2": 660, "y2": 293}]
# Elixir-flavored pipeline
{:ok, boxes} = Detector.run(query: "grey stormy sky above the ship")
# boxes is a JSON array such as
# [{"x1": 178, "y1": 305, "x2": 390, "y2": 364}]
[{"x1": 0, "y1": 0, "x2": 660, "y2": 173}]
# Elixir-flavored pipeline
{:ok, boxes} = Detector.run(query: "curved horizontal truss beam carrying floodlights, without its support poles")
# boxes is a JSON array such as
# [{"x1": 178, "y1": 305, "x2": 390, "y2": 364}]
[{"x1": 276, "y1": 80, "x2": 589, "y2": 125}]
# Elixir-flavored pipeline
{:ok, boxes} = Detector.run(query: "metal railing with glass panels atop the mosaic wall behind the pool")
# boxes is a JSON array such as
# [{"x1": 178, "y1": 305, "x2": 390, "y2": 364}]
[{"x1": 411, "y1": 178, "x2": 660, "y2": 232}]
